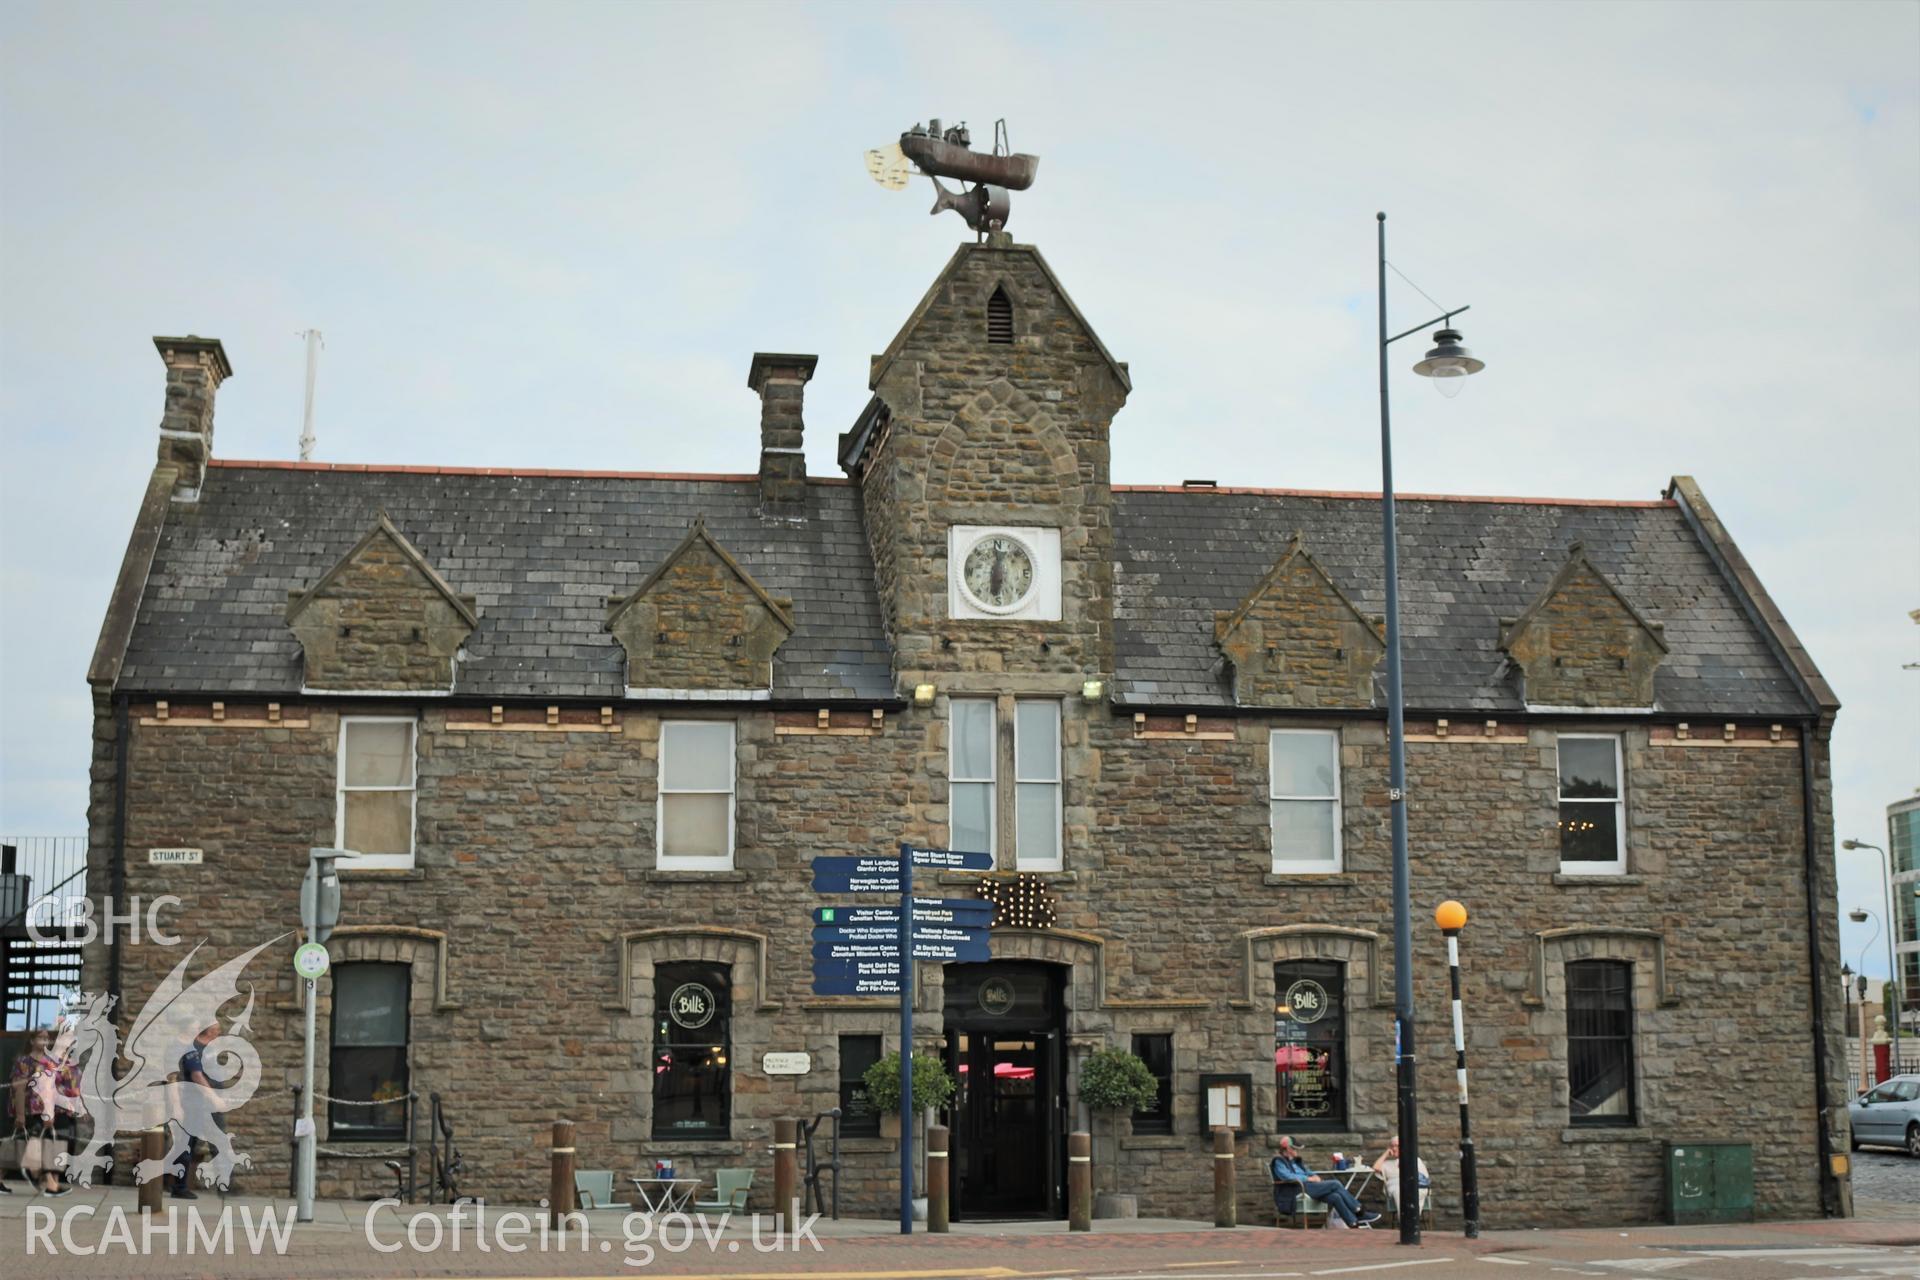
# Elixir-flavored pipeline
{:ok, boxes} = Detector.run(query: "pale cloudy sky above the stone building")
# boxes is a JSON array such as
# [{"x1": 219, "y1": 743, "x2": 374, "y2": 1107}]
[{"x1": 0, "y1": 0, "x2": 1920, "y2": 975}]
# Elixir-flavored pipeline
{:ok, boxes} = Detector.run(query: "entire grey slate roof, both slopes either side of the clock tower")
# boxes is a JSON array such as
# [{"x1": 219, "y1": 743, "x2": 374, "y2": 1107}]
[{"x1": 119, "y1": 462, "x2": 1812, "y2": 716}]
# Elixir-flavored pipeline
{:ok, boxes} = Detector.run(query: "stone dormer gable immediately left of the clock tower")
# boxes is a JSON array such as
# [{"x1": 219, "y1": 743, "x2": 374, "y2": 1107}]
[{"x1": 607, "y1": 516, "x2": 795, "y2": 697}]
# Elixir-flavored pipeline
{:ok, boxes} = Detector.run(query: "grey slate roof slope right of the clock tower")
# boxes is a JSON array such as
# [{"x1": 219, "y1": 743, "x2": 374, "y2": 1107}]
[{"x1": 1114, "y1": 487, "x2": 1814, "y2": 716}]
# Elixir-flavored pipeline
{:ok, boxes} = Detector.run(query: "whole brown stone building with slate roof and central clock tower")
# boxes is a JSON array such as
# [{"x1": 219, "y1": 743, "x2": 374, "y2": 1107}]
[{"x1": 88, "y1": 236, "x2": 1847, "y2": 1226}]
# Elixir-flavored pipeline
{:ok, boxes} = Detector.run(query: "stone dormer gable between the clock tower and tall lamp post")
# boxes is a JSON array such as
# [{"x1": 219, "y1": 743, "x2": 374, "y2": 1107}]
[{"x1": 1213, "y1": 533, "x2": 1386, "y2": 708}]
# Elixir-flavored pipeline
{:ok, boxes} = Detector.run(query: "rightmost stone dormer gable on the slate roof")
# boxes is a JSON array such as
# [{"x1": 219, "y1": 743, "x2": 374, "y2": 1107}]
[{"x1": 1500, "y1": 543, "x2": 1667, "y2": 708}]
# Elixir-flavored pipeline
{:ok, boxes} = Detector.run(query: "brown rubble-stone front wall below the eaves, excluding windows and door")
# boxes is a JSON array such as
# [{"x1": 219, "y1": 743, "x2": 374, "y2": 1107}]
[{"x1": 88, "y1": 702, "x2": 1839, "y2": 1226}]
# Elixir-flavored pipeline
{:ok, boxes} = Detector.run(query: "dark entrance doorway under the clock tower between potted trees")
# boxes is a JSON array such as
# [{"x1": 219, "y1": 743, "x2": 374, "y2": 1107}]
[{"x1": 947, "y1": 961, "x2": 1066, "y2": 1221}]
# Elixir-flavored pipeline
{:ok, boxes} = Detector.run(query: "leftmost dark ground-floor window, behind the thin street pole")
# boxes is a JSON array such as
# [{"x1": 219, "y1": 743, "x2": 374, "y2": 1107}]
[{"x1": 326, "y1": 963, "x2": 411, "y2": 1138}]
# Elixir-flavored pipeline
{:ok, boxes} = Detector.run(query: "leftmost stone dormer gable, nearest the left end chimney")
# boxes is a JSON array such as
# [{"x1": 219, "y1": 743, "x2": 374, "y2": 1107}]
[{"x1": 286, "y1": 510, "x2": 480, "y2": 693}]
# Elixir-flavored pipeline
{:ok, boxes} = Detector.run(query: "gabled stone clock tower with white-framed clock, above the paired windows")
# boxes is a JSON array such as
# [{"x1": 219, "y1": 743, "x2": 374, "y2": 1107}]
[{"x1": 841, "y1": 234, "x2": 1131, "y2": 685}]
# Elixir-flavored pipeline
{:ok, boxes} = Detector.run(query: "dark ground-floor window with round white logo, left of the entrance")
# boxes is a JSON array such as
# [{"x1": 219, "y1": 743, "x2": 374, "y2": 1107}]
[{"x1": 653, "y1": 963, "x2": 733, "y2": 1138}]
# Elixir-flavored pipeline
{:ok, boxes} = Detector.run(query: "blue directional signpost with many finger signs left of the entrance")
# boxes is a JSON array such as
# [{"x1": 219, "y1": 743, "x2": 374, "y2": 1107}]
[{"x1": 812, "y1": 844, "x2": 993, "y2": 1236}]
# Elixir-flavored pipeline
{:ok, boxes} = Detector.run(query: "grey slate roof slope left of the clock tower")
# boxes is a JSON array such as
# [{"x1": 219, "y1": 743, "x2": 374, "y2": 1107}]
[{"x1": 119, "y1": 462, "x2": 895, "y2": 700}]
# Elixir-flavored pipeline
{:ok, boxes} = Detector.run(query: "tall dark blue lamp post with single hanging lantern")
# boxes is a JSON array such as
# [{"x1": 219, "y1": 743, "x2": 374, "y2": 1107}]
[{"x1": 1379, "y1": 213, "x2": 1486, "y2": 1244}]
